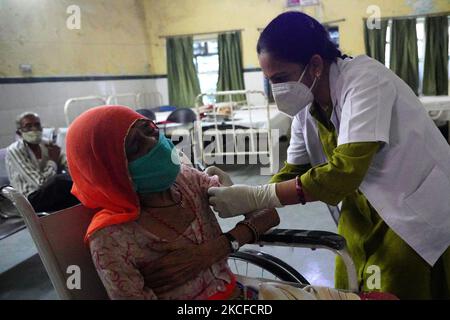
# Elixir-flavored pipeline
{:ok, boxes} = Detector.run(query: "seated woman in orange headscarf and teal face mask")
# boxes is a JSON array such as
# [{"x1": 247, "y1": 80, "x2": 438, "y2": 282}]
[{"x1": 67, "y1": 106, "x2": 279, "y2": 299}]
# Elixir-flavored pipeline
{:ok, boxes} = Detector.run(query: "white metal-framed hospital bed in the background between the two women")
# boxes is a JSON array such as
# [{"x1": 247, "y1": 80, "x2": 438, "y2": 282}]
[{"x1": 193, "y1": 90, "x2": 290, "y2": 174}]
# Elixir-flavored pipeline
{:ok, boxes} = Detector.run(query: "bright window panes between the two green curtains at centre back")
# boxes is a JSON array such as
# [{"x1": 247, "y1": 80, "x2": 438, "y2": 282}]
[{"x1": 194, "y1": 39, "x2": 219, "y2": 104}]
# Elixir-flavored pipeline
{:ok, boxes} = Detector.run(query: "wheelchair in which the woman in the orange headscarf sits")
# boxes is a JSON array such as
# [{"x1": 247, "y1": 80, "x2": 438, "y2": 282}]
[{"x1": 0, "y1": 187, "x2": 358, "y2": 300}]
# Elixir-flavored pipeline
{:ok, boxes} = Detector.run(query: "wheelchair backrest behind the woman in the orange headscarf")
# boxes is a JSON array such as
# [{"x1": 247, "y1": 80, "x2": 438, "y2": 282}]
[{"x1": 2, "y1": 187, "x2": 108, "y2": 300}]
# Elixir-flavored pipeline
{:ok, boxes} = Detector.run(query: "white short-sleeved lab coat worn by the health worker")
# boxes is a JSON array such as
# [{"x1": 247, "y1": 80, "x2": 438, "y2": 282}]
[{"x1": 287, "y1": 56, "x2": 450, "y2": 266}]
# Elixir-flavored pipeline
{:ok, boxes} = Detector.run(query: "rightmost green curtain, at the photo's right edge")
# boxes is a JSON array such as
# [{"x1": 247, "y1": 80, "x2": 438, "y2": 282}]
[{"x1": 423, "y1": 16, "x2": 448, "y2": 96}]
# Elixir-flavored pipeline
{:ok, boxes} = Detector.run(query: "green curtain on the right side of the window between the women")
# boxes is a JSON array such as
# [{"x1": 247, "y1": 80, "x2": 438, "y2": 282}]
[{"x1": 217, "y1": 32, "x2": 245, "y2": 101}]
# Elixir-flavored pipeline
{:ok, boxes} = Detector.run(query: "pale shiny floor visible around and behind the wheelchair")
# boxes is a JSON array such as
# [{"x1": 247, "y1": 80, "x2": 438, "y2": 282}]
[{"x1": 0, "y1": 141, "x2": 336, "y2": 299}]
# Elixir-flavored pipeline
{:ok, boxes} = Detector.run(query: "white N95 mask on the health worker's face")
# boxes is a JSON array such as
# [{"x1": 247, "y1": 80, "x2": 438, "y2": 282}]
[{"x1": 272, "y1": 65, "x2": 317, "y2": 117}]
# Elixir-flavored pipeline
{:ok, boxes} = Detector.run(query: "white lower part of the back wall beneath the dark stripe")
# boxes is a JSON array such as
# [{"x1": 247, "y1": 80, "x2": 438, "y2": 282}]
[{"x1": 0, "y1": 71, "x2": 264, "y2": 148}]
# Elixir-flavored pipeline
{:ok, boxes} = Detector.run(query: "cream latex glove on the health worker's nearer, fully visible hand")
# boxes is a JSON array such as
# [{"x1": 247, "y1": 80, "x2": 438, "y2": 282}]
[{"x1": 208, "y1": 183, "x2": 283, "y2": 218}]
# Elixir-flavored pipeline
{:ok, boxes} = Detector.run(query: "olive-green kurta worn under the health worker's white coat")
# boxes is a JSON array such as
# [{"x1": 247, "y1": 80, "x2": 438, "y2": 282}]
[{"x1": 271, "y1": 107, "x2": 450, "y2": 299}]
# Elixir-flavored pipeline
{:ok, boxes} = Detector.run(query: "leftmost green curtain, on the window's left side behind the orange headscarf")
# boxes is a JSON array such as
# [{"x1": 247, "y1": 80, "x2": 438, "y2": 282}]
[{"x1": 166, "y1": 37, "x2": 200, "y2": 107}]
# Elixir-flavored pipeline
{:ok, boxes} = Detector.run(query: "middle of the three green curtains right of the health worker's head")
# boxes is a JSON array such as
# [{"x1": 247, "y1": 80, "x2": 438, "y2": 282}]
[{"x1": 390, "y1": 19, "x2": 419, "y2": 95}]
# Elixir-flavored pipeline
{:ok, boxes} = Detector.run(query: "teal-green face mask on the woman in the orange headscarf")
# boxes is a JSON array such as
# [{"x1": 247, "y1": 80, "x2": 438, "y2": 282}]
[{"x1": 128, "y1": 132, "x2": 180, "y2": 193}]
